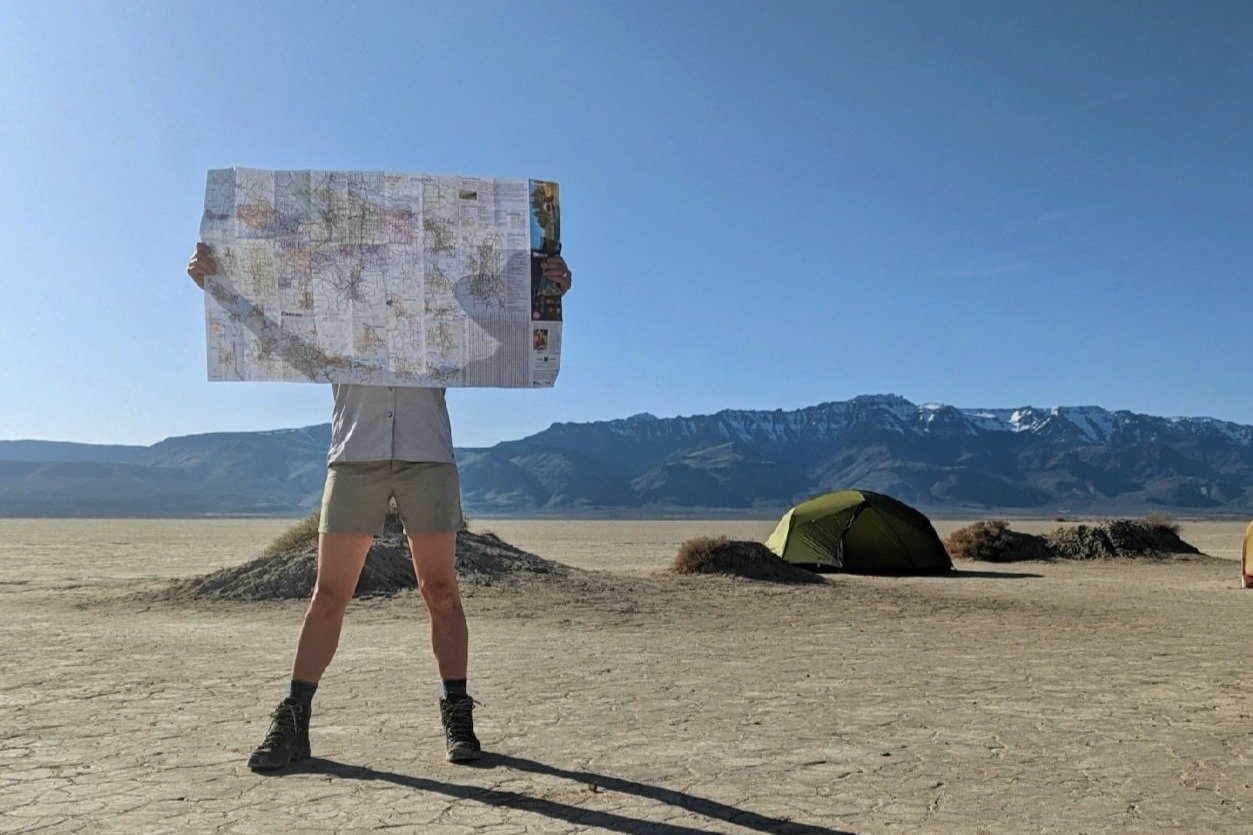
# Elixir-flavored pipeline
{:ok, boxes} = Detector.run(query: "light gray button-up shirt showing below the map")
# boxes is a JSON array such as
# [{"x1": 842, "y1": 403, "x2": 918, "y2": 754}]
[{"x1": 327, "y1": 384, "x2": 452, "y2": 464}]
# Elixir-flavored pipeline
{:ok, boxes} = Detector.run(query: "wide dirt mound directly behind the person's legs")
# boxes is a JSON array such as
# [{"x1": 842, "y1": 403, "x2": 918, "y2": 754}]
[{"x1": 162, "y1": 506, "x2": 575, "y2": 601}]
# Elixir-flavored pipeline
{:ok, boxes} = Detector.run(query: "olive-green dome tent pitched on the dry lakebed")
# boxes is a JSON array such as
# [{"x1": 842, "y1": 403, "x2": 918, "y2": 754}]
[{"x1": 766, "y1": 490, "x2": 952, "y2": 574}]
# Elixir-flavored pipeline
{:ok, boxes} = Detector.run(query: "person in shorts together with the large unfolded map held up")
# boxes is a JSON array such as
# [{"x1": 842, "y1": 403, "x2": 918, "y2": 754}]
[{"x1": 187, "y1": 169, "x2": 571, "y2": 771}]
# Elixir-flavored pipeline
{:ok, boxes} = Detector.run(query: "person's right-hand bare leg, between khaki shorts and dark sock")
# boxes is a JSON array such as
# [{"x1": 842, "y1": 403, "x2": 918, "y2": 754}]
[{"x1": 408, "y1": 533, "x2": 470, "y2": 678}]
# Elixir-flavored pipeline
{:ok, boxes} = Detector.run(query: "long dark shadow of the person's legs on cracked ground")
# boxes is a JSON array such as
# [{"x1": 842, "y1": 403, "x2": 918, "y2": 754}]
[{"x1": 282, "y1": 754, "x2": 855, "y2": 835}]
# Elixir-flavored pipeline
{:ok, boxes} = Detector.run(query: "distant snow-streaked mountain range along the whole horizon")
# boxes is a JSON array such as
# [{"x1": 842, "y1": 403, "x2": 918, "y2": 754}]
[{"x1": 0, "y1": 395, "x2": 1253, "y2": 517}]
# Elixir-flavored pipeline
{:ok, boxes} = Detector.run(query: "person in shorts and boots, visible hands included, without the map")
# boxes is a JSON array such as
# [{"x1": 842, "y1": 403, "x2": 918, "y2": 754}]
[{"x1": 187, "y1": 235, "x2": 571, "y2": 771}]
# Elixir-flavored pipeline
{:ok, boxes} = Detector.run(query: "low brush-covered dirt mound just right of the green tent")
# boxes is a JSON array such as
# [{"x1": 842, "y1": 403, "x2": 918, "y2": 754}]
[{"x1": 945, "y1": 519, "x2": 1200, "y2": 563}]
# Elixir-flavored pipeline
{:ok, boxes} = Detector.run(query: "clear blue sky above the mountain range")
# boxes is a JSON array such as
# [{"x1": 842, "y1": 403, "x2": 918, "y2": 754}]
[{"x1": 0, "y1": 0, "x2": 1253, "y2": 445}]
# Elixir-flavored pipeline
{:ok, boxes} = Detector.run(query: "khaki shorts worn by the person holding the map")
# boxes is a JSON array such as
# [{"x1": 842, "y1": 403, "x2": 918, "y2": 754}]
[{"x1": 318, "y1": 461, "x2": 462, "y2": 535}]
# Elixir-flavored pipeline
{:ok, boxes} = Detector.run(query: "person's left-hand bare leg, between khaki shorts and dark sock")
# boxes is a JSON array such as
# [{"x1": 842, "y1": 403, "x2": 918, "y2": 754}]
[{"x1": 292, "y1": 533, "x2": 375, "y2": 685}]
